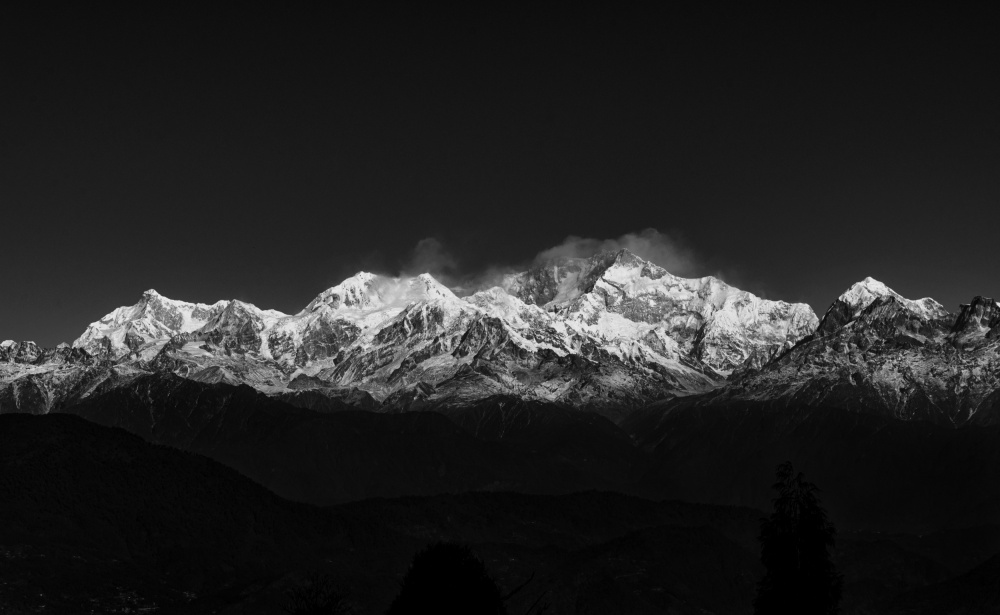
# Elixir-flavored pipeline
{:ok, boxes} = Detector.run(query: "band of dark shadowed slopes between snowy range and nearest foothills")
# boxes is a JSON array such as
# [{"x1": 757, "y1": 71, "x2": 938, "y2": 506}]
[{"x1": 41, "y1": 374, "x2": 1000, "y2": 532}]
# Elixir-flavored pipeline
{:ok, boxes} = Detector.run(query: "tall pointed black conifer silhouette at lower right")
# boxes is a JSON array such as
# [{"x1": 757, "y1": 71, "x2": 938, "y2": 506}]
[{"x1": 754, "y1": 461, "x2": 843, "y2": 615}]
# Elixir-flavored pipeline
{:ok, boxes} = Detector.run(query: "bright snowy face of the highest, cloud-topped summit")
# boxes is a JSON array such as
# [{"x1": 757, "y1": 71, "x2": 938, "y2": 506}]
[{"x1": 505, "y1": 250, "x2": 818, "y2": 374}]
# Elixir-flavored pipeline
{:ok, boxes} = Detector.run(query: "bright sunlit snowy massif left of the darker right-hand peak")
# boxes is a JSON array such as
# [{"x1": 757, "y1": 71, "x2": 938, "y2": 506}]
[{"x1": 0, "y1": 250, "x2": 817, "y2": 416}]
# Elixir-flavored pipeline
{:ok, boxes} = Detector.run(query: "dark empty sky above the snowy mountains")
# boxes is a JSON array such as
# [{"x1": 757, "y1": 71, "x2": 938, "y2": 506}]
[{"x1": 0, "y1": 3, "x2": 1000, "y2": 345}]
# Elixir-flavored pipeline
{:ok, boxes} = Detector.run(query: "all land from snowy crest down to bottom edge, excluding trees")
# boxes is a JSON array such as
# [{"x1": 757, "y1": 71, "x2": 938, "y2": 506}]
[{"x1": 0, "y1": 251, "x2": 1000, "y2": 614}]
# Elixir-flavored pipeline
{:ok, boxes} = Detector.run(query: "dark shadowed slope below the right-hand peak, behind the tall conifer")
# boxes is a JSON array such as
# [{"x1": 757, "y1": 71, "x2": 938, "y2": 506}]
[{"x1": 621, "y1": 399, "x2": 1000, "y2": 533}]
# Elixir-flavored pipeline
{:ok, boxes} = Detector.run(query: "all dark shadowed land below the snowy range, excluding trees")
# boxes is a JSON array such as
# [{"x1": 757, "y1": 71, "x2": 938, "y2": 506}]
[{"x1": 0, "y1": 376, "x2": 1000, "y2": 614}]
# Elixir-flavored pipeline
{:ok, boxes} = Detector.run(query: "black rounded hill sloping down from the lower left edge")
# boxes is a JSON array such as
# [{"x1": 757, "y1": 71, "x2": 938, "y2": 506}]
[{"x1": 0, "y1": 414, "x2": 344, "y2": 613}]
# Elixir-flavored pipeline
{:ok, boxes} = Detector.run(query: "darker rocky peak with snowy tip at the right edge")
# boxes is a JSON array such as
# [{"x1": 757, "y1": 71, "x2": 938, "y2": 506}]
[{"x1": 700, "y1": 278, "x2": 1000, "y2": 425}]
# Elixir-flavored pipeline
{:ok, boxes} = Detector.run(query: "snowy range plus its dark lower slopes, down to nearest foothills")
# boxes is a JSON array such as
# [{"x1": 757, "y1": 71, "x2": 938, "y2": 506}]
[{"x1": 0, "y1": 251, "x2": 1000, "y2": 531}]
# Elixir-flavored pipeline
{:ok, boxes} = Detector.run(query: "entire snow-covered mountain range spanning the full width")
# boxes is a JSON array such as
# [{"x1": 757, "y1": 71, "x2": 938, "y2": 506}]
[{"x1": 0, "y1": 250, "x2": 1000, "y2": 425}]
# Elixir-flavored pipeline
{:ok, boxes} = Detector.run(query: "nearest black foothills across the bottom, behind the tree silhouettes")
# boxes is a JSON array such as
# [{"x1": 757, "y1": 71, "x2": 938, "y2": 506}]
[{"x1": 0, "y1": 414, "x2": 1000, "y2": 614}]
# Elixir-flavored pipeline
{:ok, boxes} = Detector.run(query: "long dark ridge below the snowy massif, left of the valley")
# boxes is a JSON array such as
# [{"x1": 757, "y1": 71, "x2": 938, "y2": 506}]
[{"x1": 56, "y1": 374, "x2": 648, "y2": 505}]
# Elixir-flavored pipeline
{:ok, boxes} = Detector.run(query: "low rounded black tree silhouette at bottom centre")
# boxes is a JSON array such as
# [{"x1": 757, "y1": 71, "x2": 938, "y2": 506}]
[{"x1": 387, "y1": 542, "x2": 507, "y2": 615}]
